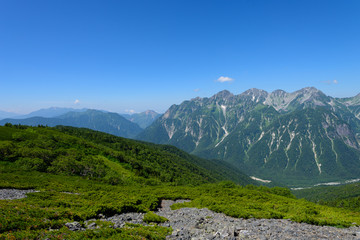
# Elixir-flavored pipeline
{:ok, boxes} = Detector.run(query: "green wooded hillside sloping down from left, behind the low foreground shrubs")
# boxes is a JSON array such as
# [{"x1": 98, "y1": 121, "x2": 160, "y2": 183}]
[{"x1": 0, "y1": 124, "x2": 252, "y2": 185}]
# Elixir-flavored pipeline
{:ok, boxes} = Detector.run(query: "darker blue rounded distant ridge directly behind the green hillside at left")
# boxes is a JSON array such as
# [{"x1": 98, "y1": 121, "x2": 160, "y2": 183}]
[{"x1": 0, "y1": 110, "x2": 142, "y2": 138}]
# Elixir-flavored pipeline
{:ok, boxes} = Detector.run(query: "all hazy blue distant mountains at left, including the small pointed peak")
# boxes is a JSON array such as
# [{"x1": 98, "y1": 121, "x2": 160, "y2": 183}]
[{"x1": 0, "y1": 107, "x2": 160, "y2": 138}]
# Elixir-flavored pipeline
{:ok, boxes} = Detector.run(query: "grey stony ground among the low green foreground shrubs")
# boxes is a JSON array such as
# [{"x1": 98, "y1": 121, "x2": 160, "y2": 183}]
[{"x1": 0, "y1": 189, "x2": 360, "y2": 240}]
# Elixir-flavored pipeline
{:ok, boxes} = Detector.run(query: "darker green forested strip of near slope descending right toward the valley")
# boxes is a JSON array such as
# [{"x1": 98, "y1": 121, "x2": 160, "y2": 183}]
[{"x1": 56, "y1": 126, "x2": 256, "y2": 185}]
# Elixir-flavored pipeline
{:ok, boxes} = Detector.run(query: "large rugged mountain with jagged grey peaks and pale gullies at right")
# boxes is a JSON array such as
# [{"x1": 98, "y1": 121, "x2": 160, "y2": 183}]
[{"x1": 138, "y1": 88, "x2": 360, "y2": 186}]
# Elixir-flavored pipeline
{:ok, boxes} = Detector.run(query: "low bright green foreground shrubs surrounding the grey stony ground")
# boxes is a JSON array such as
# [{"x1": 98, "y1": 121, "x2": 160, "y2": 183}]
[{"x1": 0, "y1": 165, "x2": 360, "y2": 239}]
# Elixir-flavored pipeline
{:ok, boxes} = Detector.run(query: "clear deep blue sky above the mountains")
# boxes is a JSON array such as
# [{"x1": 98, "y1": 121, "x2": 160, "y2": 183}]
[{"x1": 0, "y1": 0, "x2": 360, "y2": 113}]
